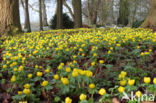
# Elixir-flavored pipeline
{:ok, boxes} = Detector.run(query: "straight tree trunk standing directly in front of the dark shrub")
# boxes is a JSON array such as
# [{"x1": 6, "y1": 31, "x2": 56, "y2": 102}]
[{"x1": 57, "y1": 0, "x2": 63, "y2": 29}]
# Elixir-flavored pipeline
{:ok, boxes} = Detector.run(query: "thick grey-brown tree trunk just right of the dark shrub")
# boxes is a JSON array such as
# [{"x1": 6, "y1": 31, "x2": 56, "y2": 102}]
[{"x1": 72, "y1": 0, "x2": 82, "y2": 28}]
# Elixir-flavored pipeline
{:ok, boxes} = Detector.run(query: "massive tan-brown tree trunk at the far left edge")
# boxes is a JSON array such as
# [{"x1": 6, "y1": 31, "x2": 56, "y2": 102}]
[{"x1": 0, "y1": 0, "x2": 21, "y2": 35}]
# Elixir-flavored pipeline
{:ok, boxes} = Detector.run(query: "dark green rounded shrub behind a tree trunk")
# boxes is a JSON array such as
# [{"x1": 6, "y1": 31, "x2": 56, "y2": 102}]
[{"x1": 50, "y1": 13, "x2": 74, "y2": 29}]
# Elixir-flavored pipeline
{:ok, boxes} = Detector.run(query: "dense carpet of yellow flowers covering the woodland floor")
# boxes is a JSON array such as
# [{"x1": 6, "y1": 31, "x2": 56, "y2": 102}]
[{"x1": 0, "y1": 28, "x2": 156, "y2": 103}]
